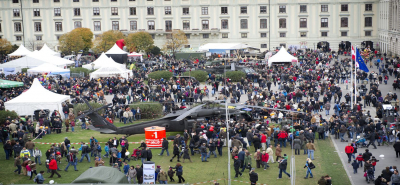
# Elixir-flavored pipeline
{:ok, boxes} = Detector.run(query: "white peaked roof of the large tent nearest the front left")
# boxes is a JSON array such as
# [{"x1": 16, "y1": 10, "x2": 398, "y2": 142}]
[{"x1": 5, "y1": 78, "x2": 70, "y2": 106}]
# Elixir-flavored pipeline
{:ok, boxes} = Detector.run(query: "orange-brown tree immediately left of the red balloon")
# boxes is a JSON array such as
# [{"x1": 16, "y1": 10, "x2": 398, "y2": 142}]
[{"x1": 93, "y1": 30, "x2": 125, "y2": 53}]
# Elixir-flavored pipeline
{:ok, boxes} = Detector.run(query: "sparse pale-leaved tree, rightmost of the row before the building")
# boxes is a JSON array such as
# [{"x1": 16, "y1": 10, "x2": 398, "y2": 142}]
[{"x1": 164, "y1": 30, "x2": 189, "y2": 57}]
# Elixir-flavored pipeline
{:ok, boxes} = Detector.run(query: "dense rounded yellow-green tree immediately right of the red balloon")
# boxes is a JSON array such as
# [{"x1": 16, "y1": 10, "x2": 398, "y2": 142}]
[{"x1": 125, "y1": 31, "x2": 154, "y2": 52}]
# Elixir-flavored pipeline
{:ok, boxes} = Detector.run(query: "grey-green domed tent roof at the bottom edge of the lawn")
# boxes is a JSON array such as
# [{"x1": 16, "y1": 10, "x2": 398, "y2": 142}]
[{"x1": 72, "y1": 166, "x2": 129, "y2": 184}]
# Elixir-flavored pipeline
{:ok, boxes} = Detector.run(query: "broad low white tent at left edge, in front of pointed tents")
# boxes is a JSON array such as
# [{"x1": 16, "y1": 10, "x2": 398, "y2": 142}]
[{"x1": 0, "y1": 51, "x2": 74, "y2": 71}]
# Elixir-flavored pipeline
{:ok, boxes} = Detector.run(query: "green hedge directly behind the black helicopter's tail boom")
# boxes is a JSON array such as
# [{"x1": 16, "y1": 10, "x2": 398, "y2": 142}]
[{"x1": 129, "y1": 103, "x2": 163, "y2": 119}]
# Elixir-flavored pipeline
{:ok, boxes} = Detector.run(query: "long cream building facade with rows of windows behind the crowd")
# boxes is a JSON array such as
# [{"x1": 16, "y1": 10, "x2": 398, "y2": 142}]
[{"x1": 0, "y1": 0, "x2": 380, "y2": 51}]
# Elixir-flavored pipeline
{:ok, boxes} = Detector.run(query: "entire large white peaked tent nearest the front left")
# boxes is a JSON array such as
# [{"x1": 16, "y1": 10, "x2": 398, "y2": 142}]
[{"x1": 4, "y1": 78, "x2": 70, "y2": 115}]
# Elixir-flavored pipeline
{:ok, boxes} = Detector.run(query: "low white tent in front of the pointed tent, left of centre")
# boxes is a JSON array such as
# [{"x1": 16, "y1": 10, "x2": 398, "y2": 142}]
[{"x1": 90, "y1": 66, "x2": 133, "y2": 79}]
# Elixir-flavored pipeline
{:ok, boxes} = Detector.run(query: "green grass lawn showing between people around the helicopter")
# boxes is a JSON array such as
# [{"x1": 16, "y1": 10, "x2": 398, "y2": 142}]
[{"x1": 0, "y1": 123, "x2": 350, "y2": 185}]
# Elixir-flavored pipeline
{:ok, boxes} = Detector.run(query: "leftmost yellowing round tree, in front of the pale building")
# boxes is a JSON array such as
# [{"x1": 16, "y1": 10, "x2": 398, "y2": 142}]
[{"x1": 58, "y1": 32, "x2": 85, "y2": 55}]
